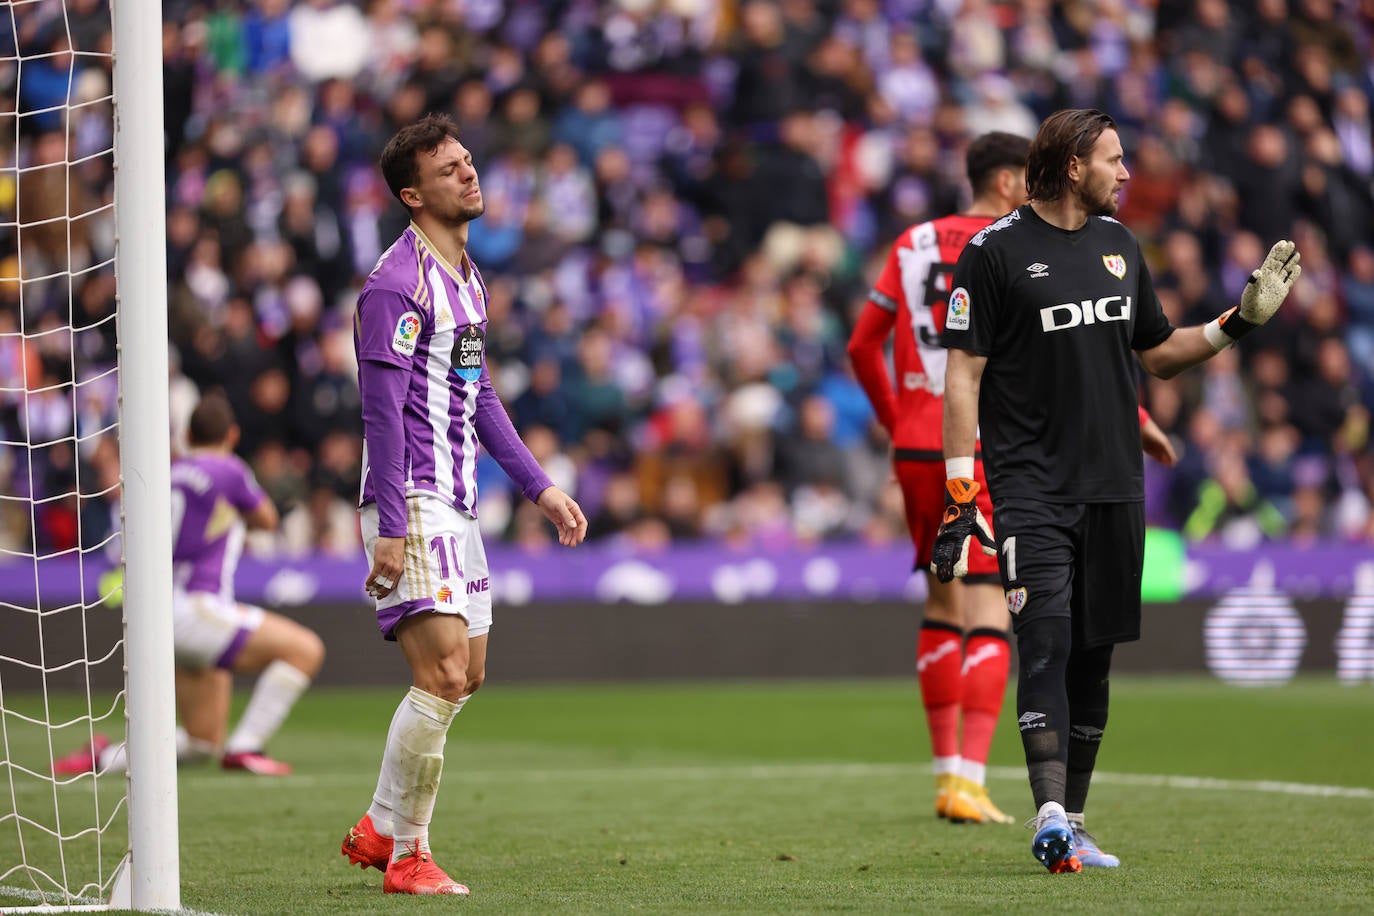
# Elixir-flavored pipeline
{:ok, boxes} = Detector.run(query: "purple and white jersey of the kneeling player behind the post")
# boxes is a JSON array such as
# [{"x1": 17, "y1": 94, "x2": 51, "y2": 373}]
[{"x1": 172, "y1": 452, "x2": 267, "y2": 600}]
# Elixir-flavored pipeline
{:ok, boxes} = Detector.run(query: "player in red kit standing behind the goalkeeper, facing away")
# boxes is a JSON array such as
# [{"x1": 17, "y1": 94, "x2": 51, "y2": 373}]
[{"x1": 849, "y1": 132, "x2": 1031, "y2": 824}]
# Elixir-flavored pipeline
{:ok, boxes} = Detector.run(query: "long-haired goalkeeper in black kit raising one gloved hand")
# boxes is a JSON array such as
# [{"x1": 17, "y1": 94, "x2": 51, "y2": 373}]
[{"x1": 932, "y1": 110, "x2": 1301, "y2": 873}]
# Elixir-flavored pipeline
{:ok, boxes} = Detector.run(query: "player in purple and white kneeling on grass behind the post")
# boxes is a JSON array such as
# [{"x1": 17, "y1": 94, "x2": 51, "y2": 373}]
[{"x1": 54, "y1": 391, "x2": 324, "y2": 776}]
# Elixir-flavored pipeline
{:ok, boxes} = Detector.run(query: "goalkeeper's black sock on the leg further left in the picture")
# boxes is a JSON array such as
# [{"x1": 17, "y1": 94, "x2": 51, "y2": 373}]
[{"x1": 1017, "y1": 617, "x2": 1073, "y2": 809}]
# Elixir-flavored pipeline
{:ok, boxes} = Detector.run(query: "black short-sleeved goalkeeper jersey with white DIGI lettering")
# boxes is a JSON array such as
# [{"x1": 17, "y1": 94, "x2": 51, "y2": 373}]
[{"x1": 940, "y1": 206, "x2": 1173, "y2": 503}]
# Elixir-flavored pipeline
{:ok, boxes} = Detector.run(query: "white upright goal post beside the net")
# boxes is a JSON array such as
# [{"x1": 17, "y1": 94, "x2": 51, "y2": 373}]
[{"x1": 110, "y1": 0, "x2": 181, "y2": 911}]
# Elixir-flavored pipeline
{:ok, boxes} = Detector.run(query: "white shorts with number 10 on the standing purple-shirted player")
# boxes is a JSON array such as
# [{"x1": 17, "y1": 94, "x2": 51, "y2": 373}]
[{"x1": 359, "y1": 494, "x2": 492, "y2": 640}]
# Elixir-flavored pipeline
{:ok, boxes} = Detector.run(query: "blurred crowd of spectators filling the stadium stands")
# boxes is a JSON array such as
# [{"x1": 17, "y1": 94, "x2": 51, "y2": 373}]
[{"x1": 0, "y1": 0, "x2": 1374, "y2": 563}]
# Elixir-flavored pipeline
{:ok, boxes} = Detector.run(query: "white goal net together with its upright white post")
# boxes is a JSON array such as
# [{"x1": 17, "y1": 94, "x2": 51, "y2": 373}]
[{"x1": 0, "y1": 0, "x2": 180, "y2": 912}]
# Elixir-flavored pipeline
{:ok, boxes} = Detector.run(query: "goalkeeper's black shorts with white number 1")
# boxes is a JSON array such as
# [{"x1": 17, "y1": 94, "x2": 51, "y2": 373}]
[{"x1": 992, "y1": 500, "x2": 1145, "y2": 648}]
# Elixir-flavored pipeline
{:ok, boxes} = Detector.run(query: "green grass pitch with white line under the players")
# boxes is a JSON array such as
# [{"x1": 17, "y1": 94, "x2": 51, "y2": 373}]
[{"x1": 0, "y1": 677, "x2": 1374, "y2": 915}]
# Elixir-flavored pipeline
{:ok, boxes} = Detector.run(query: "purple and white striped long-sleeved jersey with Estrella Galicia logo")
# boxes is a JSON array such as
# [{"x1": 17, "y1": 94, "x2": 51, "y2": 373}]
[{"x1": 353, "y1": 222, "x2": 550, "y2": 537}]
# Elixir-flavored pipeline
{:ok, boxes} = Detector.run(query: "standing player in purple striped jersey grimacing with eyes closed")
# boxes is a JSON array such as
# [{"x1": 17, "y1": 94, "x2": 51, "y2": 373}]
[{"x1": 342, "y1": 114, "x2": 587, "y2": 894}]
